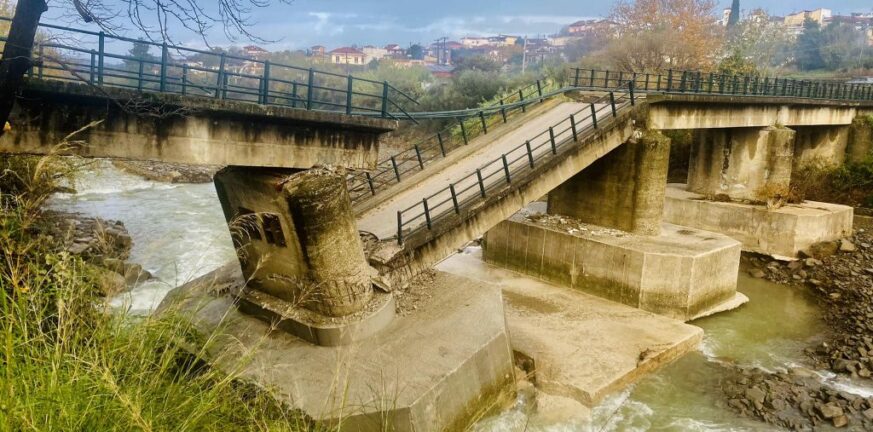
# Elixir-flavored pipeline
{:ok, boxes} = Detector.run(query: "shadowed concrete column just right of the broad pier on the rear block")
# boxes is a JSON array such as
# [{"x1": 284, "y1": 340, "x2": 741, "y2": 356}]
[{"x1": 793, "y1": 126, "x2": 849, "y2": 170}]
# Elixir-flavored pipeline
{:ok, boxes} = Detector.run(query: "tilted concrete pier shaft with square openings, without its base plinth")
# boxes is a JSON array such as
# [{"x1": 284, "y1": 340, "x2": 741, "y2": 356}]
[{"x1": 215, "y1": 167, "x2": 373, "y2": 317}]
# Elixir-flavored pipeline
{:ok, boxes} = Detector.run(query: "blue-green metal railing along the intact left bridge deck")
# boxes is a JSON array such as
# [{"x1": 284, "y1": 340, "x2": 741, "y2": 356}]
[{"x1": 0, "y1": 17, "x2": 418, "y2": 119}]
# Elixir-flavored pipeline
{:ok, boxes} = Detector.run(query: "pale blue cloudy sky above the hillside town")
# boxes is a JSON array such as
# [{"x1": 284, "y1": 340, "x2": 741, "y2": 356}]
[{"x1": 44, "y1": 0, "x2": 873, "y2": 50}]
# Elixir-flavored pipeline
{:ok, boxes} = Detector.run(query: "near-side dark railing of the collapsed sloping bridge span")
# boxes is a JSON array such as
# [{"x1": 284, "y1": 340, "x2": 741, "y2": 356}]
[{"x1": 397, "y1": 82, "x2": 636, "y2": 244}]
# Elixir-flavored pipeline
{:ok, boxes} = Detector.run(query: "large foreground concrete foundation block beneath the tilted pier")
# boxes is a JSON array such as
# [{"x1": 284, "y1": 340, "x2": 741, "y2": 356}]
[{"x1": 158, "y1": 263, "x2": 514, "y2": 432}]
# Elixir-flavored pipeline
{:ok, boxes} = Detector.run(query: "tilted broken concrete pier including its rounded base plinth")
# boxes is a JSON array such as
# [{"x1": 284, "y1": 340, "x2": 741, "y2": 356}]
[{"x1": 215, "y1": 167, "x2": 394, "y2": 346}]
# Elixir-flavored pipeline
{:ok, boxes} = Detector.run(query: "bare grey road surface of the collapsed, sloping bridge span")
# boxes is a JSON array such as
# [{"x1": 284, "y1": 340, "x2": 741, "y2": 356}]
[{"x1": 358, "y1": 102, "x2": 599, "y2": 239}]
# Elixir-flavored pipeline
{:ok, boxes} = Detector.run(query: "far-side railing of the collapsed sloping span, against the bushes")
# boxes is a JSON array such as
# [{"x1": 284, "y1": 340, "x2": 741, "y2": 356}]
[{"x1": 348, "y1": 80, "x2": 560, "y2": 204}]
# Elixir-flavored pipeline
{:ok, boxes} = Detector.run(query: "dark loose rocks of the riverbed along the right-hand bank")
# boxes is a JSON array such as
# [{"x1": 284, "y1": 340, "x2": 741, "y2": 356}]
[{"x1": 723, "y1": 216, "x2": 873, "y2": 430}]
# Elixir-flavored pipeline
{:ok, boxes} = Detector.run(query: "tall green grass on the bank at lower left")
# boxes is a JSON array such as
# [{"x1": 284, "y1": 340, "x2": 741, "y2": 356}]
[{"x1": 0, "y1": 149, "x2": 321, "y2": 431}]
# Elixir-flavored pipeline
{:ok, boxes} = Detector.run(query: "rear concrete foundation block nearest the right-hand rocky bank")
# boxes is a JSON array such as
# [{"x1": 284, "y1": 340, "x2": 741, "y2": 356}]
[{"x1": 664, "y1": 184, "x2": 852, "y2": 259}]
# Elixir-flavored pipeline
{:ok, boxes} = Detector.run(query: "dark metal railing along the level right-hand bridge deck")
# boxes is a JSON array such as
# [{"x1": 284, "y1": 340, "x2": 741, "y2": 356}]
[{"x1": 570, "y1": 68, "x2": 873, "y2": 101}]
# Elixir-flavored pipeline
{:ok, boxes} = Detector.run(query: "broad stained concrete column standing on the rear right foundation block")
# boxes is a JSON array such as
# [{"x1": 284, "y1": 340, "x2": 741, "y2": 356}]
[{"x1": 688, "y1": 126, "x2": 795, "y2": 201}]
